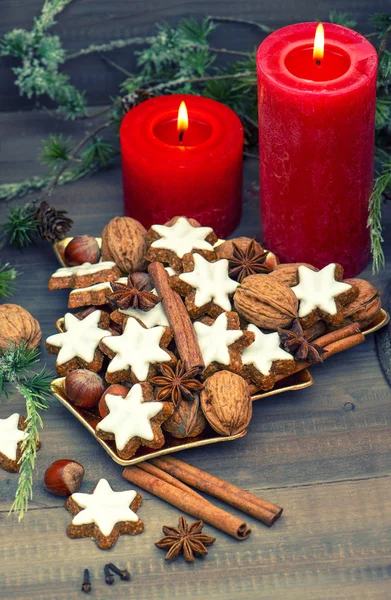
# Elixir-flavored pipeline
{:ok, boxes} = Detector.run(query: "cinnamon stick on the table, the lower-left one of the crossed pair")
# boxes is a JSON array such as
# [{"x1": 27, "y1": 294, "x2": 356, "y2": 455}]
[{"x1": 122, "y1": 466, "x2": 251, "y2": 540}]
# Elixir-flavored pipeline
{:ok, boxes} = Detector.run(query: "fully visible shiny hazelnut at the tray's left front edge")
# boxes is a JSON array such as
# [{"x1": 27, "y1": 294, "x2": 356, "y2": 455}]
[{"x1": 65, "y1": 369, "x2": 105, "y2": 408}]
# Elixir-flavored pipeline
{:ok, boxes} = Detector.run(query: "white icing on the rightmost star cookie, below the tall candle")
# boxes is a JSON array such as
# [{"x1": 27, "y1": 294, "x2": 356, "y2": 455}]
[{"x1": 291, "y1": 263, "x2": 352, "y2": 318}]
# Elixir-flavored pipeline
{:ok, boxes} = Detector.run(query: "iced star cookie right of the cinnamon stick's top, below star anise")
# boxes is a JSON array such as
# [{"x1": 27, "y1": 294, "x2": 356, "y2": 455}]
[{"x1": 170, "y1": 254, "x2": 239, "y2": 319}]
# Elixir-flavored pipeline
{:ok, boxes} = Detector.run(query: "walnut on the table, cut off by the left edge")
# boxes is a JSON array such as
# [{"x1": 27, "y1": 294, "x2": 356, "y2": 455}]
[{"x1": 0, "y1": 304, "x2": 42, "y2": 352}]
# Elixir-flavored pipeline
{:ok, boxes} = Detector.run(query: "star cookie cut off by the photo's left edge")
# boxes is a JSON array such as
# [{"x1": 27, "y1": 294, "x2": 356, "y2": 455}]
[{"x1": 0, "y1": 413, "x2": 27, "y2": 473}]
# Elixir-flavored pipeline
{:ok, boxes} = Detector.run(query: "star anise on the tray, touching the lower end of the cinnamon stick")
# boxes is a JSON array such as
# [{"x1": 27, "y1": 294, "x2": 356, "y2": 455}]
[{"x1": 151, "y1": 360, "x2": 203, "y2": 406}]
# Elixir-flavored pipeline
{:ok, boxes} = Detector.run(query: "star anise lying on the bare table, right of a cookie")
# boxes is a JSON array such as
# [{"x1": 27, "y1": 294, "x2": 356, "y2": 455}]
[{"x1": 155, "y1": 517, "x2": 216, "y2": 562}]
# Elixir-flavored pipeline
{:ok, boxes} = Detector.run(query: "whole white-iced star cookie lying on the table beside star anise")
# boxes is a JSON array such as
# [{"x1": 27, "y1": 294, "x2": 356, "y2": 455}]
[{"x1": 65, "y1": 479, "x2": 144, "y2": 550}]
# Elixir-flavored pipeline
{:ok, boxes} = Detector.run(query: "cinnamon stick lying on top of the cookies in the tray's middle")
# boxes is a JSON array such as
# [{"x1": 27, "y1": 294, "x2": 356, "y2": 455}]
[{"x1": 148, "y1": 262, "x2": 205, "y2": 370}]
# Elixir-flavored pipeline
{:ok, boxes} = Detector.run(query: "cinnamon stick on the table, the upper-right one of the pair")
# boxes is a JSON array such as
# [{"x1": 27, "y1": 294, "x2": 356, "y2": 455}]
[{"x1": 151, "y1": 456, "x2": 283, "y2": 527}]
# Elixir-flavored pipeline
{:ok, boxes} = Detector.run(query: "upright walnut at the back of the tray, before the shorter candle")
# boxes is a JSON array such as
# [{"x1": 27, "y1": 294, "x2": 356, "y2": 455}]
[{"x1": 102, "y1": 217, "x2": 147, "y2": 273}]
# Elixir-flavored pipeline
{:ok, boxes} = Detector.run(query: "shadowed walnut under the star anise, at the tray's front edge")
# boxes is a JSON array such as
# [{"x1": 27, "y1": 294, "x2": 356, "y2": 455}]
[{"x1": 163, "y1": 394, "x2": 206, "y2": 439}]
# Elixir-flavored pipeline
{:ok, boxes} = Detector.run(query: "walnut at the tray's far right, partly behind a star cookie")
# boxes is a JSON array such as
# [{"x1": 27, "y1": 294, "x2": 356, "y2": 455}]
[{"x1": 342, "y1": 279, "x2": 381, "y2": 328}]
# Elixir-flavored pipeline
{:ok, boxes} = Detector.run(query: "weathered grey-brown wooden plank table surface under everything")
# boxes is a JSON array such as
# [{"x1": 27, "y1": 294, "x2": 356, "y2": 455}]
[{"x1": 0, "y1": 113, "x2": 391, "y2": 600}]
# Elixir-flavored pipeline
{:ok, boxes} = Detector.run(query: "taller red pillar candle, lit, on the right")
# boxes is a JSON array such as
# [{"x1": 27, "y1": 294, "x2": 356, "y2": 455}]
[{"x1": 257, "y1": 23, "x2": 377, "y2": 277}]
